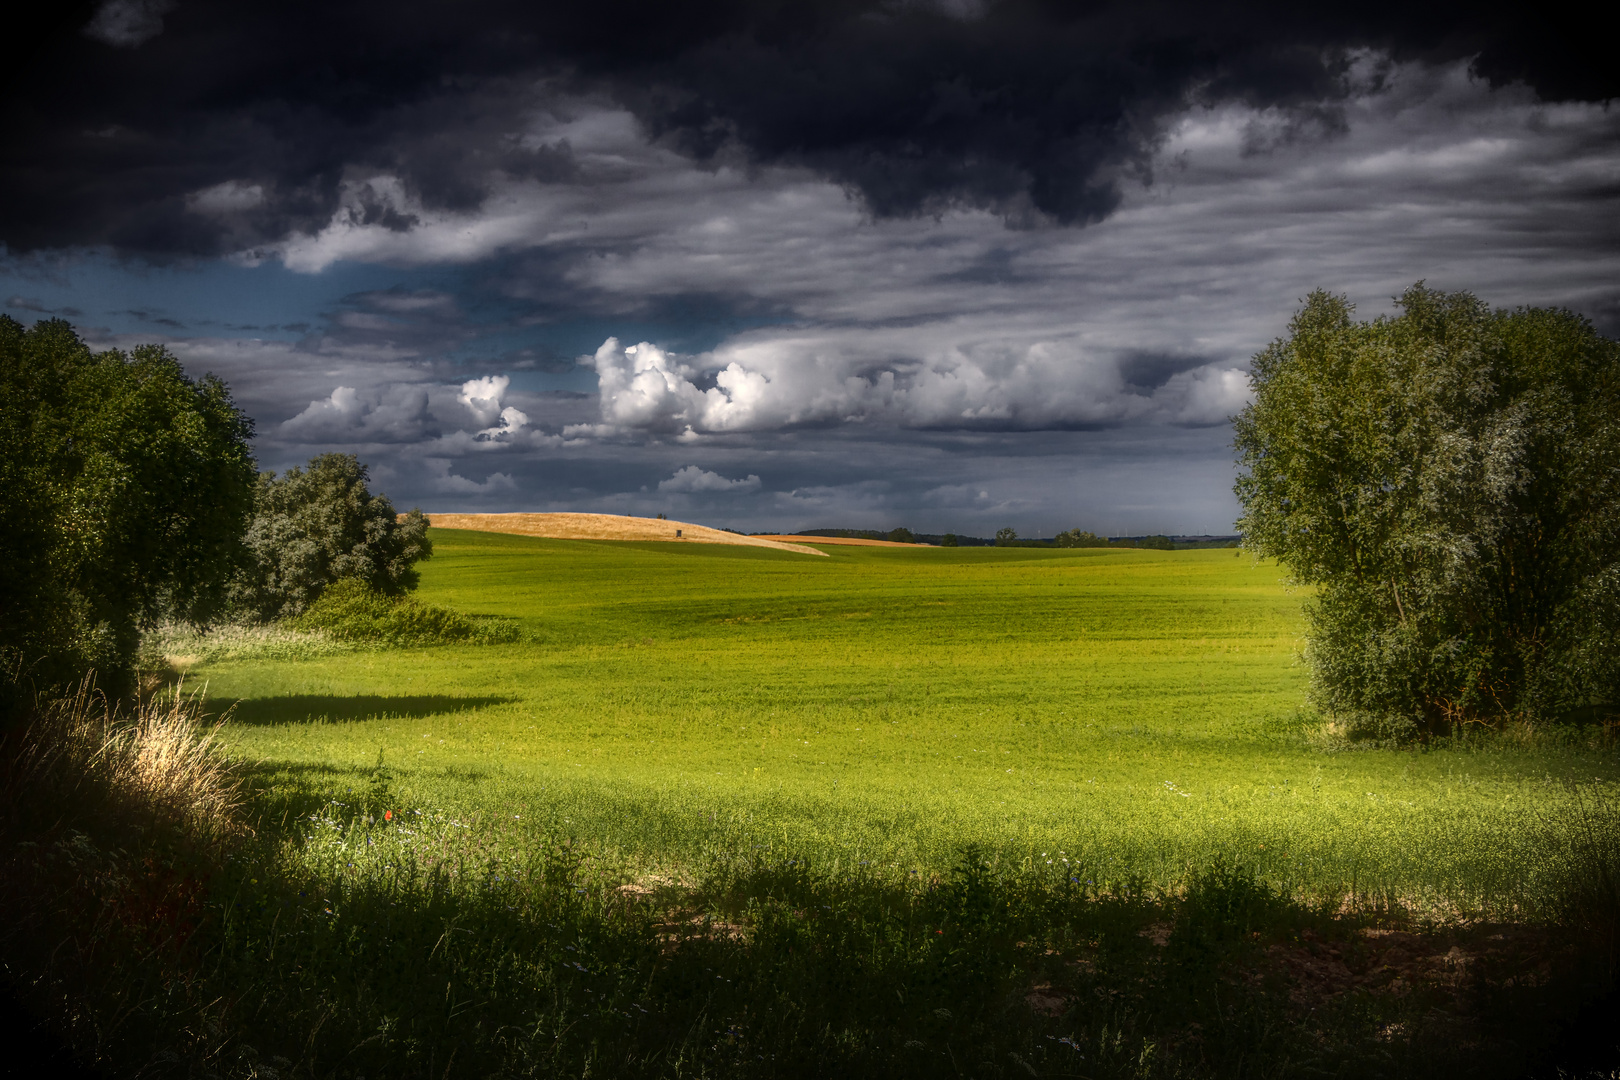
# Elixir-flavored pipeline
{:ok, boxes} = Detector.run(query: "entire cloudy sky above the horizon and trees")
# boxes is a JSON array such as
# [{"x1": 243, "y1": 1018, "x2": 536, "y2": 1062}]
[{"x1": 0, "y1": 0, "x2": 1620, "y2": 536}]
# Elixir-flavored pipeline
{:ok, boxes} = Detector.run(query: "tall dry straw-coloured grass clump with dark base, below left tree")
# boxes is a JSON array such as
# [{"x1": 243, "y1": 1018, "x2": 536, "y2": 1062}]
[{"x1": 0, "y1": 678, "x2": 249, "y2": 1064}]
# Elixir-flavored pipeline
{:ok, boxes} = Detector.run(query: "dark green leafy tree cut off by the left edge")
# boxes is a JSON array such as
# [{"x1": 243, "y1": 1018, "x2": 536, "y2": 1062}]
[{"x1": 0, "y1": 316, "x2": 254, "y2": 703}]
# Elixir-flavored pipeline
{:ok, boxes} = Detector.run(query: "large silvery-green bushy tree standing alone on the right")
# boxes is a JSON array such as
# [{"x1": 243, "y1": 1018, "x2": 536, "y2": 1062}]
[{"x1": 1236, "y1": 283, "x2": 1620, "y2": 733}]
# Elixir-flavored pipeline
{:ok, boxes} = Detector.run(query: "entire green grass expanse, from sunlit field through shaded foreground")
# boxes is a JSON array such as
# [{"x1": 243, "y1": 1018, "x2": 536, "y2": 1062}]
[{"x1": 6, "y1": 531, "x2": 1620, "y2": 1078}]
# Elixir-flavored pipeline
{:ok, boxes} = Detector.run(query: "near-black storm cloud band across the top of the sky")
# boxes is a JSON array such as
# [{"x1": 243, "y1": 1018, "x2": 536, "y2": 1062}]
[{"x1": 0, "y1": 0, "x2": 1620, "y2": 254}]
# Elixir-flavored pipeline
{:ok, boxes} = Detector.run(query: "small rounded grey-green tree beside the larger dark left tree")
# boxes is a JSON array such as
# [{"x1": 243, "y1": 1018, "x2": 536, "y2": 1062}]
[{"x1": 233, "y1": 453, "x2": 433, "y2": 619}]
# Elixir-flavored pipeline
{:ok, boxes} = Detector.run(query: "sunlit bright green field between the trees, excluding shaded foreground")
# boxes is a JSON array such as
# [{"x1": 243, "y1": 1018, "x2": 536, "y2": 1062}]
[{"x1": 199, "y1": 531, "x2": 1617, "y2": 907}]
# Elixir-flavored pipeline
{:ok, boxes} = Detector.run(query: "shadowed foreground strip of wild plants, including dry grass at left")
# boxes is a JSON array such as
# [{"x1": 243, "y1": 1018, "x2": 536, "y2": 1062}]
[{"x1": 0, "y1": 693, "x2": 1620, "y2": 1077}]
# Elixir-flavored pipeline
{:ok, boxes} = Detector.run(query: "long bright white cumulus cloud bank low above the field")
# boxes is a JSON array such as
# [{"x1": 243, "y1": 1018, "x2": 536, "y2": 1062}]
[{"x1": 565, "y1": 329, "x2": 1249, "y2": 437}]
